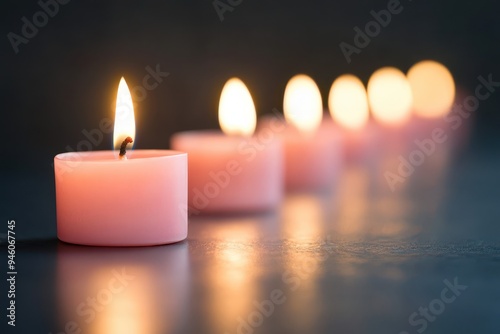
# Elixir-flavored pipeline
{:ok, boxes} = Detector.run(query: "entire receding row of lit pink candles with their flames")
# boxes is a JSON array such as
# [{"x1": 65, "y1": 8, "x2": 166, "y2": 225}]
[{"x1": 54, "y1": 61, "x2": 454, "y2": 246}]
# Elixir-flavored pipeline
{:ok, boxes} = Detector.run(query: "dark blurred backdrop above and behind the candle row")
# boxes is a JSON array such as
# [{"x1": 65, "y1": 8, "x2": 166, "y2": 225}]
[{"x1": 0, "y1": 0, "x2": 500, "y2": 234}]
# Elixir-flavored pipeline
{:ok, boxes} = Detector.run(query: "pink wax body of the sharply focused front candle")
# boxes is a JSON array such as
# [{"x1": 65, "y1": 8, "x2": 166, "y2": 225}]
[{"x1": 54, "y1": 150, "x2": 187, "y2": 246}]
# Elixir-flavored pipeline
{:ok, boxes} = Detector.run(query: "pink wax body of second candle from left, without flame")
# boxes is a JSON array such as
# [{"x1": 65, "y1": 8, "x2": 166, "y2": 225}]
[{"x1": 171, "y1": 130, "x2": 283, "y2": 214}]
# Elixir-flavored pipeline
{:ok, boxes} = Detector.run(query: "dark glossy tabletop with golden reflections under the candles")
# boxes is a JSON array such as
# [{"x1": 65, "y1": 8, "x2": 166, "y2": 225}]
[{"x1": 1, "y1": 149, "x2": 500, "y2": 334}]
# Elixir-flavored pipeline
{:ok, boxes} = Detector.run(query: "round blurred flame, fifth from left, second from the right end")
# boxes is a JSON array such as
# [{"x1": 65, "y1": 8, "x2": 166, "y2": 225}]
[{"x1": 368, "y1": 67, "x2": 412, "y2": 125}]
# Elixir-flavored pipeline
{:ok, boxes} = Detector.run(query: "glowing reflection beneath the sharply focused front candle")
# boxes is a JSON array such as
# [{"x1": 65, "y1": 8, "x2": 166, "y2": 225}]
[{"x1": 57, "y1": 243, "x2": 189, "y2": 334}]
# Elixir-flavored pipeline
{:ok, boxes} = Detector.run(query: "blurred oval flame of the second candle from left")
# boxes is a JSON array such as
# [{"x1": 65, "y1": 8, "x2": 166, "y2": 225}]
[{"x1": 219, "y1": 78, "x2": 257, "y2": 136}]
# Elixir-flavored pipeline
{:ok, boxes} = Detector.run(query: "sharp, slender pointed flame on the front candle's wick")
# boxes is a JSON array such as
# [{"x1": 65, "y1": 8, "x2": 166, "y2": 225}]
[{"x1": 113, "y1": 77, "x2": 135, "y2": 150}]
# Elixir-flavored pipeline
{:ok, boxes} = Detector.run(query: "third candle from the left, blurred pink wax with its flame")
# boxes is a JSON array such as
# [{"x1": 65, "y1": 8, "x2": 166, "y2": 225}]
[{"x1": 281, "y1": 74, "x2": 341, "y2": 190}]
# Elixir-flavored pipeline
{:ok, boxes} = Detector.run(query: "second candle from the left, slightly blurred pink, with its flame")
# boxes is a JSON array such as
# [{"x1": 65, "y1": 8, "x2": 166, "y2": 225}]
[{"x1": 171, "y1": 78, "x2": 283, "y2": 214}]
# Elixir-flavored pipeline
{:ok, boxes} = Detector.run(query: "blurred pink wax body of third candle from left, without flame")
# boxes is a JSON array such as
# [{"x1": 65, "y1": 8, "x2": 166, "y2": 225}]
[{"x1": 259, "y1": 118, "x2": 342, "y2": 190}]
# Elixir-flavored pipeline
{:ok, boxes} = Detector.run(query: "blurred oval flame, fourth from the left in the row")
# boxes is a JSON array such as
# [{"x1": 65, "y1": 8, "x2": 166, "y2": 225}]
[{"x1": 328, "y1": 74, "x2": 368, "y2": 130}]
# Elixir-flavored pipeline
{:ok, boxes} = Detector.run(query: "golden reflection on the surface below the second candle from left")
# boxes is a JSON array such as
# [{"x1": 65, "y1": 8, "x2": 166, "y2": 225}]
[{"x1": 190, "y1": 215, "x2": 266, "y2": 333}]
